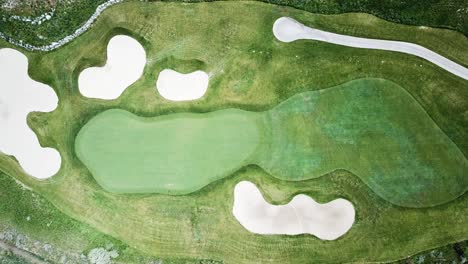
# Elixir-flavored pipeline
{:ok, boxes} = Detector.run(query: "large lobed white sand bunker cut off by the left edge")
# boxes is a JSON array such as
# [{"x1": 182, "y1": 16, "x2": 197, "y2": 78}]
[{"x1": 0, "y1": 49, "x2": 62, "y2": 179}]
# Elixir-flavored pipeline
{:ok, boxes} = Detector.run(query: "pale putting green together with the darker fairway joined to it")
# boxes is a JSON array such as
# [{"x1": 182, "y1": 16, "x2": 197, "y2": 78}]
[{"x1": 76, "y1": 79, "x2": 468, "y2": 207}]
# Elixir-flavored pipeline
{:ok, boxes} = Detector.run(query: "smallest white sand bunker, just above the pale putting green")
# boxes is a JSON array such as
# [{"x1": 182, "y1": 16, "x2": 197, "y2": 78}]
[{"x1": 156, "y1": 69, "x2": 210, "y2": 101}]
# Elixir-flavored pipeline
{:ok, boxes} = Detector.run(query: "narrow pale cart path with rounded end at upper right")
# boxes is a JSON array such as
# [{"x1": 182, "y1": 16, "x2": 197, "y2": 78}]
[{"x1": 273, "y1": 17, "x2": 468, "y2": 80}]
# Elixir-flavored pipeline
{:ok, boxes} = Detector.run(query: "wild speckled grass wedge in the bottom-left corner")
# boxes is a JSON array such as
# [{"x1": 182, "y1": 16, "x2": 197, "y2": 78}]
[{"x1": 0, "y1": 171, "x2": 150, "y2": 263}]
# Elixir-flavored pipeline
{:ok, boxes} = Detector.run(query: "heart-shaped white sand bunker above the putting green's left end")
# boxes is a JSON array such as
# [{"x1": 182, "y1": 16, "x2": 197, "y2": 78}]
[{"x1": 78, "y1": 35, "x2": 146, "y2": 100}]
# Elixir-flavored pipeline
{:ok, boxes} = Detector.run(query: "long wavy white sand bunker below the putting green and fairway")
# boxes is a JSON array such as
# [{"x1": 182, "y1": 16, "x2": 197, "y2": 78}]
[{"x1": 232, "y1": 181, "x2": 355, "y2": 240}]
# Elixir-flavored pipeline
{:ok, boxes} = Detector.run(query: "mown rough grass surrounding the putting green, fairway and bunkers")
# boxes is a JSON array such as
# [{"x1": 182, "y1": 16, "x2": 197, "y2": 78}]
[{"x1": 0, "y1": 2, "x2": 468, "y2": 263}]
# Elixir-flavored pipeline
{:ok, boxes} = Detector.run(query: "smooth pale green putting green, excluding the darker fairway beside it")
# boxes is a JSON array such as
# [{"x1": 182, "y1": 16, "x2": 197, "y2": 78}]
[{"x1": 75, "y1": 109, "x2": 261, "y2": 194}]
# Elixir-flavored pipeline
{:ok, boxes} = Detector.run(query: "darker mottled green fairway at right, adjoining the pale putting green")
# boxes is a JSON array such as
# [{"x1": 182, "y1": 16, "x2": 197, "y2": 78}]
[{"x1": 258, "y1": 79, "x2": 468, "y2": 207}]
